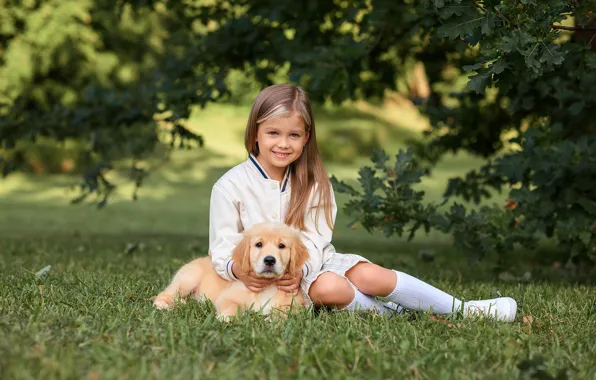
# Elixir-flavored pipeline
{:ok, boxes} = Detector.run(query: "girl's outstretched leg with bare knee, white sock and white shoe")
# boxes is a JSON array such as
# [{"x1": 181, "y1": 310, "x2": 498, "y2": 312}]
[{"x1": 346, "y1": 263, "x2": 517, "y2": 321}]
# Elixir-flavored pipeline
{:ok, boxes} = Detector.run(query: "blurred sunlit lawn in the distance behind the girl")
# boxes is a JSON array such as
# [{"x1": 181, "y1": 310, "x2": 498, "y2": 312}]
[{"x1": 0, "y1": 93, "x2": 488, "y2": 243}]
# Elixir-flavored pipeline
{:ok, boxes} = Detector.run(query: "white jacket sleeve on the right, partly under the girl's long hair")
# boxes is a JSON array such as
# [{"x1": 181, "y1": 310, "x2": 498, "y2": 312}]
[{"x1": 302, "y1": 185, "x2": 337, "y2": 272}]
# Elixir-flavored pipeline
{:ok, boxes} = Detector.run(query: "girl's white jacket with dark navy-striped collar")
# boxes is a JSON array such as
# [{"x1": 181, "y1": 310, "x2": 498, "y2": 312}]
[{"x1": 209, "y1": 155, "x2": 337, "y2": 281}]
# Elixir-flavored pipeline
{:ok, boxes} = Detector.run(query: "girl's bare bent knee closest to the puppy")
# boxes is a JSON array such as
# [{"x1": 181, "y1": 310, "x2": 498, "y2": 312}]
[{"x1": 308, "y1": 272, "x2": 354, "y2": 306}]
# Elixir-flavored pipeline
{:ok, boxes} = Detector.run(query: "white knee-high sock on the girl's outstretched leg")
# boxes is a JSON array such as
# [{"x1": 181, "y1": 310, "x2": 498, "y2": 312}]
[{"x1": 385, "y1": 270, "x2": 462, "y2": 314}]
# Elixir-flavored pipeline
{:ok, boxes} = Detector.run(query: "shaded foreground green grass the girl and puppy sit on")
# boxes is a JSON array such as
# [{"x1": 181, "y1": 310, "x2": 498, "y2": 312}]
[{"x1": 0, "y1": 236, "x2": 596, "y2": 379}]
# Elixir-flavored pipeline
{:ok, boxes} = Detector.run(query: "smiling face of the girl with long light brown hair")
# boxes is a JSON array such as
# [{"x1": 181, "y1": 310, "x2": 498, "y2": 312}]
[{"x1": 257, "y1": 112, "x2": 309, "y2": 180}]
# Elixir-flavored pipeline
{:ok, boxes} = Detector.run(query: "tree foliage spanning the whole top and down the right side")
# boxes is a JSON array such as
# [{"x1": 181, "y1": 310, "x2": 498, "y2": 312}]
[{"x1": 0, "y1": 0, "x2": 596, "y2": 258}]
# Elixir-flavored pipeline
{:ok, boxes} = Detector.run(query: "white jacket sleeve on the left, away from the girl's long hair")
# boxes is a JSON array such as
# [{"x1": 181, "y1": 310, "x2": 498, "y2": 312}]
[{"x1": 209, "y1": 183, "x2": 243, "y2": 281}]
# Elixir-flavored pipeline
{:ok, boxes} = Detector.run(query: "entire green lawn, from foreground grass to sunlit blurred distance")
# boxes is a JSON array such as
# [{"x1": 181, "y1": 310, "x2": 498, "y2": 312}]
[{"x1": 0, "y1": 102, "x2": 596, "y2": 379}]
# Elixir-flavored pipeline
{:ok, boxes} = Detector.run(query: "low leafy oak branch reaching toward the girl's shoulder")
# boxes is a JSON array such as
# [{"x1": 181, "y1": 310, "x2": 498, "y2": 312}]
[{"x1": 331, "y1": 149, "x2": 537, "y2": 257}]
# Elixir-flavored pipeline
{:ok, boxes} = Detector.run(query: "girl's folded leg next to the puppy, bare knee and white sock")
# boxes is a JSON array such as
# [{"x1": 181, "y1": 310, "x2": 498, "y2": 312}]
[{"x1": 308, "y1": 272, "x2": 399, "y2": 314}]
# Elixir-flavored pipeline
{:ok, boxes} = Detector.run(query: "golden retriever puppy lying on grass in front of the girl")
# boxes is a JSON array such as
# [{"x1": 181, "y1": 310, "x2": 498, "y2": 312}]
[{"x1": 153, "y1": 223, "x2": 308, "y2": 321}]
